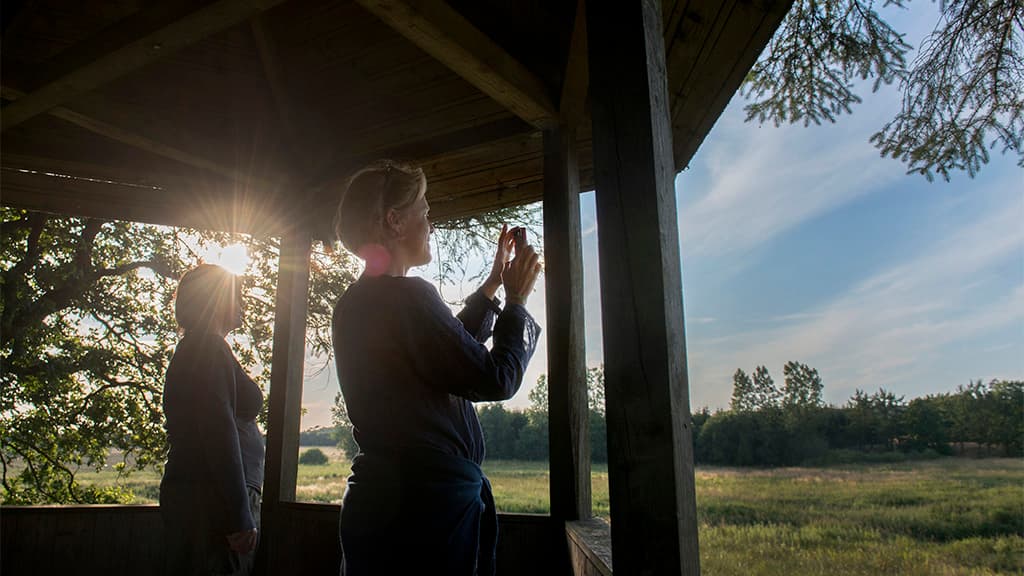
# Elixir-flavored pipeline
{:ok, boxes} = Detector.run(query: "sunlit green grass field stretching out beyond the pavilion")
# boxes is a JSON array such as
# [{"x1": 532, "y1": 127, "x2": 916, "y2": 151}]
[{"x1": 72, "y1": 449, "x2": 1024, "y2": 576}]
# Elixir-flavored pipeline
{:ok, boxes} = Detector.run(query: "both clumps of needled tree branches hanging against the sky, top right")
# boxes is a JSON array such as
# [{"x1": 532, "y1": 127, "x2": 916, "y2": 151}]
[{"x1": 741, "y1": 0, "x2": 1024, "y2": 180}]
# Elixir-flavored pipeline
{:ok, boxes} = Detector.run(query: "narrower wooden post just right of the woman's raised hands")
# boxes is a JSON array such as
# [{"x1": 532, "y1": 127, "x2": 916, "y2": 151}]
[{"x1": 544, "y1": 123, "x2": 591, "y2": 522}]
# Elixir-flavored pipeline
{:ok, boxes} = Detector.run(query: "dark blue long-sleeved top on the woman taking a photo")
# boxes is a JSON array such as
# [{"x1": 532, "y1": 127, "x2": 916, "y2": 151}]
[{"x1": 333, "y1": 276, "x2": 541, "y2": 464}]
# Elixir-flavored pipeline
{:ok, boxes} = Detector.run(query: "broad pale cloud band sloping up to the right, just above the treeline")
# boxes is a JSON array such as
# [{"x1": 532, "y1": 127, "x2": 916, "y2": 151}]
[{"x1": 689, "y1": 186, "x2": 1024, "y2": 406}]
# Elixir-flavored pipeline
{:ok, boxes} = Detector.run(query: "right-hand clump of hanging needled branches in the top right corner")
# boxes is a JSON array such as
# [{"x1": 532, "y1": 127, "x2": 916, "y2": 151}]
[{"x1": 871, "y1": 0, "x2": 1024, "y2": 180}]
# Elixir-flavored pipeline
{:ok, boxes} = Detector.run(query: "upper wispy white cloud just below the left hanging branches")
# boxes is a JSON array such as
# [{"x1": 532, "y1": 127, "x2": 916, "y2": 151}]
[{"x1": 679, "y1": 110, "x2": 904, "y2": 257}]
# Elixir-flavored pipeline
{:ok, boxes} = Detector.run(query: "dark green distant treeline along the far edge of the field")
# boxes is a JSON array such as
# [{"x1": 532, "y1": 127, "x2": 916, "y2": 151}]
[{"x1": 315, "y1": 362, "x2": 1024, "y2": 466}]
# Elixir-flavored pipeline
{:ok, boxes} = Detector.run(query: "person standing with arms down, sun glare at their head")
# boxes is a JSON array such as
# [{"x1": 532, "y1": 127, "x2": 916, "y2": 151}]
[{"x1": 160, "y1": 264, "x2": 264, "y2": 575}]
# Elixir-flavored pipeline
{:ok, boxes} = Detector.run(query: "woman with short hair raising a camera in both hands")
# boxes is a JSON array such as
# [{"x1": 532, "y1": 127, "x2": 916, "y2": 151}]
[{"x1": 333, "y1": 161, "x2": 541, "y2": 576}]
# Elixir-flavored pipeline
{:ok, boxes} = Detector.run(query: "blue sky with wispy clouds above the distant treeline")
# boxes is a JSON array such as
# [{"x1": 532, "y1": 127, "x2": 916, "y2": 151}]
[{"x1": 302, "y1": 4, "x2": 1024, "y2": 429}]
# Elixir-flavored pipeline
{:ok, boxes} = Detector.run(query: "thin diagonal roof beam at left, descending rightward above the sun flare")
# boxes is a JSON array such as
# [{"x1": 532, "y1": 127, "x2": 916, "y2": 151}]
[{"x1": 2, "y1": 86, "x2": 285, "y2": 193}]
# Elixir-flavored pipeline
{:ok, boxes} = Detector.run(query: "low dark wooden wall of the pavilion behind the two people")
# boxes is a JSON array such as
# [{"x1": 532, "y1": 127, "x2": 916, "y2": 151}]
[{"x1": 0, "y1": 503, "x2": 571, "y2": 576}]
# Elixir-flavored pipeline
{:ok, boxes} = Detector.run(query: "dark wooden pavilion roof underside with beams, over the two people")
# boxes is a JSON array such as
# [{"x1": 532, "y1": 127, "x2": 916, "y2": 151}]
[{"x1": 0, "y1": 0, "x2": 791, "y2": 233}]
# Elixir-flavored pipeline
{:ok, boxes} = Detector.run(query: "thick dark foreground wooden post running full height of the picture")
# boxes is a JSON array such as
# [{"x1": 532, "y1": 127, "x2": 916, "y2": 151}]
[{"x1": 587, "y1": 0, "x2": 700, "y2": 576}]
